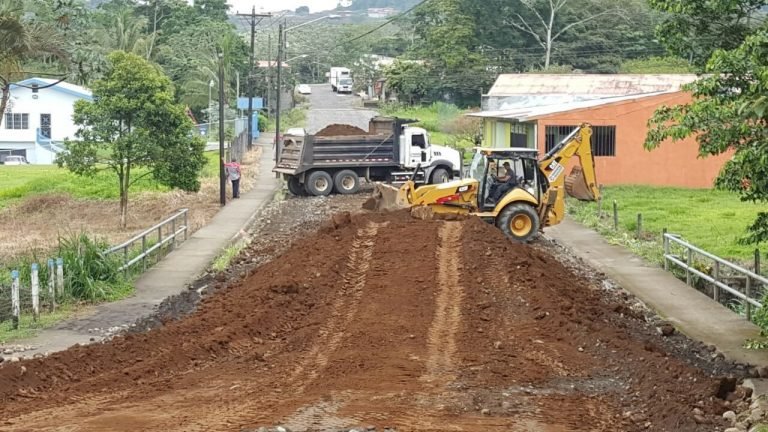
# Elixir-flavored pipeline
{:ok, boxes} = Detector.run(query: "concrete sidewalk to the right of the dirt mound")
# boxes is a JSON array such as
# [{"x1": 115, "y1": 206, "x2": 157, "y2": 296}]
[{"x1": 545, "y1": 218, "x2": 768, "y2": 366}]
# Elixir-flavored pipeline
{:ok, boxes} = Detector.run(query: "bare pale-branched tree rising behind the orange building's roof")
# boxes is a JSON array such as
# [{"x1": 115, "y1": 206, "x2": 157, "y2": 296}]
[{"x1": 506, "y1": 0, "x2": 622, "y2": 69}]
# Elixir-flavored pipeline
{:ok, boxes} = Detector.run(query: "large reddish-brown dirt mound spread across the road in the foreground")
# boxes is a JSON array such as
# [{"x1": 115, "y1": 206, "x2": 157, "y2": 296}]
[{"x1": 0, "y1": 212, "x2": 748, "y2": 432}]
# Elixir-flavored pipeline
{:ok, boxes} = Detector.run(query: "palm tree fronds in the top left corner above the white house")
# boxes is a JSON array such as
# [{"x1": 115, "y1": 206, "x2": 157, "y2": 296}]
[{"x1": 0, "y1": 0, "x2": 66, "y2": 125}]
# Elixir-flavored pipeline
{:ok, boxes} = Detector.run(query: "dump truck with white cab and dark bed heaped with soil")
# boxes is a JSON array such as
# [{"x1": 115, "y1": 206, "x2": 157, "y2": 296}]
[{"x1": 272, "y1": 116, "x2": 462, "y2": 196}]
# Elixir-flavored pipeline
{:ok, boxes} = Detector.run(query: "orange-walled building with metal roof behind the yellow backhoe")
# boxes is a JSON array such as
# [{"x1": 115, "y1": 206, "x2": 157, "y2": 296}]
[{"x1": 468, "y1": 74, "x2": 731, "y2": 187}]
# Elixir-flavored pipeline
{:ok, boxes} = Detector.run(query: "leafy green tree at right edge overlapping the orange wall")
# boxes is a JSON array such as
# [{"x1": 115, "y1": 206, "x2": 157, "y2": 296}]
[{"x1": 645, "y1": 29, "x2": 768, "y2": 243}]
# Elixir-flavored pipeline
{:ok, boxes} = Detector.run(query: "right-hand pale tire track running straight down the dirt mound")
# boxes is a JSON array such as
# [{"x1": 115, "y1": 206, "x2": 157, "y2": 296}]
[{"x1": 422, "y1": 222, "x2": 464, "y2": 385}]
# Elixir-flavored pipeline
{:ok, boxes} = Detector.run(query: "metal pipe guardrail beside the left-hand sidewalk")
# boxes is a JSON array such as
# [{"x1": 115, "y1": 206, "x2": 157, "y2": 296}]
[{"x1": 104, "y1": 208, "x2": 189, "y2": 275}]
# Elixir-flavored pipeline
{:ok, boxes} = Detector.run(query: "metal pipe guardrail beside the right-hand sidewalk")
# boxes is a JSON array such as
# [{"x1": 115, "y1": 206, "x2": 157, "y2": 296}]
[{"x1": 664, "y1": 232, "x2": 768, "y2": 320}]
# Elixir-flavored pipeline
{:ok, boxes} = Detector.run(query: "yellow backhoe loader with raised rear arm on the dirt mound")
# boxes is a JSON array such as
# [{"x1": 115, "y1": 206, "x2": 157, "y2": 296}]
[{"x1": 365, "y1": 123, "x2": 600, "y2": 243}]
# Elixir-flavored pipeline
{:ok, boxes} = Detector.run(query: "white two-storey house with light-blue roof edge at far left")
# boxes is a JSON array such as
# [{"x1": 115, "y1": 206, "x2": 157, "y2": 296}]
[{"x1": 0, "y1": 78, "x2": 93, "y2": 164}]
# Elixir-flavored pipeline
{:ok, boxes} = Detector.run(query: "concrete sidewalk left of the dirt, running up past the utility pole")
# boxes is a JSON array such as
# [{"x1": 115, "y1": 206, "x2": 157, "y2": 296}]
[{"x1": 3, "y1": 134, "x2": 278, "y2": 357}]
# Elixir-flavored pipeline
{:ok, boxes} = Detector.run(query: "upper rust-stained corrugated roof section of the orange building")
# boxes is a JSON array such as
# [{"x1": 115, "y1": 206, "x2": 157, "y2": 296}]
[{"x1": 488, "y1": 74, "x2": 698, "y2": 96}]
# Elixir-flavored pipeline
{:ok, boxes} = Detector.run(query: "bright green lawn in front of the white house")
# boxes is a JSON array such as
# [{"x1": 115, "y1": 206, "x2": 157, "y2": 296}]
[{"x1": 0, "y1": 165, "x2": 167, "y2": 208}]
